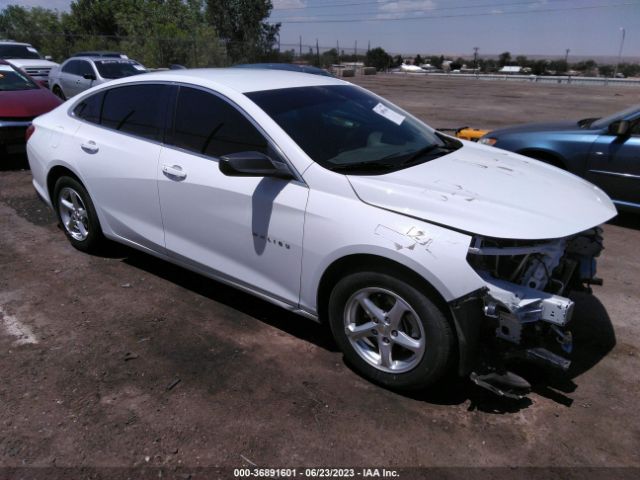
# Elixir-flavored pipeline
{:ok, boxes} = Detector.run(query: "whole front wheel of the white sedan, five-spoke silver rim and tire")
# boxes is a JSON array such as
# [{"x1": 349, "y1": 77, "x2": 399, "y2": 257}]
[{"x1": 329, "y1": 272, "x2": 455, "y2": 390}]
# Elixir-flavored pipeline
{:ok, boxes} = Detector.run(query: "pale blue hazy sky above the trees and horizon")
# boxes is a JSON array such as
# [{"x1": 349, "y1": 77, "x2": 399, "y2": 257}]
[{"x1": 0, "y1": 0, "x2": 640, "y2": 61}]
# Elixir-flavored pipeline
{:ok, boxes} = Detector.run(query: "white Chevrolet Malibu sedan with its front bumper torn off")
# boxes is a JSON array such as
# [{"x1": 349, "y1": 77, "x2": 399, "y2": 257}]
[{"x1": 27, "y1": 69, "x2": 616, "y2": 397}]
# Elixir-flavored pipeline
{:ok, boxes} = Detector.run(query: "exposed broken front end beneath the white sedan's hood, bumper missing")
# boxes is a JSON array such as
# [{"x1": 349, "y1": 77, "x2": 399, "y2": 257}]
[{"x1": 467, "y1": 228, "x2": 603, "y2": 398}]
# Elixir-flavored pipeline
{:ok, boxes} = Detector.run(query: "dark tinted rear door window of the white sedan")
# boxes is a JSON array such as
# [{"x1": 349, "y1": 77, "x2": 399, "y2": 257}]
[{"x1": 101, "y1": 85, "x2": 171, "y2": 141}]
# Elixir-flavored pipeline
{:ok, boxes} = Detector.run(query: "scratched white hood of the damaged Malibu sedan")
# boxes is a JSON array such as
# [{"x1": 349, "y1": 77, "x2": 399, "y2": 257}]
[{"x1": 348, "y1": 142, "x2": 616, "y2": 240}]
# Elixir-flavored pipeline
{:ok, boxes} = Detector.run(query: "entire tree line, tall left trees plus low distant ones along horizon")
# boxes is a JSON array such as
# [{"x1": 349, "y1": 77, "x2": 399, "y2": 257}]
[{"x1": 0, "y1": 0, "x2": 640, "y2": 77}]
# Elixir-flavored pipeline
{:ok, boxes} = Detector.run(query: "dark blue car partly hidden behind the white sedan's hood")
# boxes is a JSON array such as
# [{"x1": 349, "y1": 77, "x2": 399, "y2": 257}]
[{"x1": 479, "y1": 105, "x2": 640, "y2": 212}]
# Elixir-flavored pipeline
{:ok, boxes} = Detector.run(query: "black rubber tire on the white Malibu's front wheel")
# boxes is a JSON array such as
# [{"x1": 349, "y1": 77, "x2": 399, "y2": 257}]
[{"x1": 328, "y1": 272, "x2": 455, "y2": 390}]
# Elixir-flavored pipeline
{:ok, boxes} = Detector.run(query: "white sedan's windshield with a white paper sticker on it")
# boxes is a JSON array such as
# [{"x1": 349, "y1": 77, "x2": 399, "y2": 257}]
[{"x1": 246, "y1": 85, "x2": 462, "y2": 174}]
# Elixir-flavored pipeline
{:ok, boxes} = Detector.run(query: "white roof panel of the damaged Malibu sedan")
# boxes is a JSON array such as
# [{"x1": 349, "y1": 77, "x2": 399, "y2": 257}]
[{"x1": 109, "y1": 68, "x2": 351, "y2": 93}]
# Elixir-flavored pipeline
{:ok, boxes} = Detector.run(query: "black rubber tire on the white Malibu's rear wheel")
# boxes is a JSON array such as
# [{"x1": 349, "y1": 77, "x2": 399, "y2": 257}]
[{"x1": 52, "y1": 177, "x2": 104, "y2": 253}]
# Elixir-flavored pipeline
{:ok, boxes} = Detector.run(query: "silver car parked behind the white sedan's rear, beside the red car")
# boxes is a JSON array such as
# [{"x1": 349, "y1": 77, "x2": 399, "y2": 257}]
[{"x1": 49, "y1": 56, "x2": 147, "y2": 100}]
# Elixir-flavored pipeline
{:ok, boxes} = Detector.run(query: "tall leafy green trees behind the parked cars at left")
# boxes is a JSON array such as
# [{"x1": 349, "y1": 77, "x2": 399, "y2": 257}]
[{"x1": 0, "y1": 0, "x2": 280, "y2": 67}]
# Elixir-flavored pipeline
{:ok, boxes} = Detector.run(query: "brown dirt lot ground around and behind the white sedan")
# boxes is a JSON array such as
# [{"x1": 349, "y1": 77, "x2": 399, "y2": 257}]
[{"x1": 0, "y1": 75, "x2": 640, "y2": 478}]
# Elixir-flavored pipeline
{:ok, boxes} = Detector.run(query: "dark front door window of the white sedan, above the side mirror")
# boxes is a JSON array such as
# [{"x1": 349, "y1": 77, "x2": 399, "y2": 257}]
[{"x1": 173, "y1": 87, "x2": 267, "y2": 157}]
